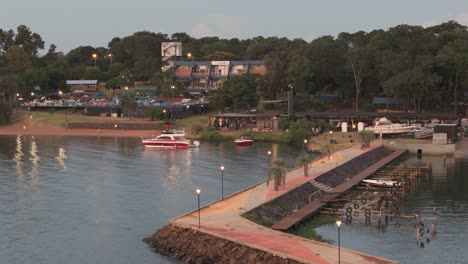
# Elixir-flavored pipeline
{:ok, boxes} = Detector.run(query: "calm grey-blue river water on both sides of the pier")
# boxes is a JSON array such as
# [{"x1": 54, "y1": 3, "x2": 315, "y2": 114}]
[{"x1": 0, "y1": 136, "x2": 468, "y2": 264}]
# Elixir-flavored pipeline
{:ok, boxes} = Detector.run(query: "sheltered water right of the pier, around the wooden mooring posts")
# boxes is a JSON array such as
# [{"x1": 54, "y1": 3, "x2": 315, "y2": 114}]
[{"x1": 316, "y1": 156, "x2": 468, "y2": 264}]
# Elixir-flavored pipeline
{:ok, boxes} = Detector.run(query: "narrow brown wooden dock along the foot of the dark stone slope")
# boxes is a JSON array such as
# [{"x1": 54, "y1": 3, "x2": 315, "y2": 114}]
[{"x1": 271, "y1": 149, "x2": 406, "y2": 231}]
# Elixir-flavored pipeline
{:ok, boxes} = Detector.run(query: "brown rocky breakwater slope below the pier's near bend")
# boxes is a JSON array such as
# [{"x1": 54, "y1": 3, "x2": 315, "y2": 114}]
[{"x1": 143, "y1": 224, "x2": 303, "y2": 264}]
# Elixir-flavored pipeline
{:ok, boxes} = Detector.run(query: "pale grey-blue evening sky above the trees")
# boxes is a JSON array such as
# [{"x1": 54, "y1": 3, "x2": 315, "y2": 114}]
[{"x1": 0, "y1": 0, "x2": 468, "y2": 53}]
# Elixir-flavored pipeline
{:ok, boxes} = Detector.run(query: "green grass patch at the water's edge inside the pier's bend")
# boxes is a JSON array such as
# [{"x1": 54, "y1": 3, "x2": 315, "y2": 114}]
[{"x1": 290, "y1": 214, "x2": 336, "y2": 243}]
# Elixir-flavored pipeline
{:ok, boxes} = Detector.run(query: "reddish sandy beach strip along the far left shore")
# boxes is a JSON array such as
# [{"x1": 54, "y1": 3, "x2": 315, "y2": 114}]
[{"x1": 0, "y1": 122, "x2": 161, "y2": 137}]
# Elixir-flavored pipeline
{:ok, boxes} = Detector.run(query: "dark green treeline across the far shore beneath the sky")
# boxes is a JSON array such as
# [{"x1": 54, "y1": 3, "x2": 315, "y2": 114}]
[{"x1": 0, "y1": 21, "x2": 468, "y2": 111}]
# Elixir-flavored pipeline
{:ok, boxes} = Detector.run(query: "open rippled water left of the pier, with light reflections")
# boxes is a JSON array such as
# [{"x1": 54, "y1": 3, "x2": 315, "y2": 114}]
[{"x1": 0, "y1": 136, "x2": 300, "y2": 264}]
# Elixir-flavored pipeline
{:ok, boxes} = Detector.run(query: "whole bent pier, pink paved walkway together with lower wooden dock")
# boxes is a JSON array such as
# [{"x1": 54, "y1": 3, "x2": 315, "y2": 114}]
[{"x1": 149, "y1": 142, "x2": 405, "y2": 264}]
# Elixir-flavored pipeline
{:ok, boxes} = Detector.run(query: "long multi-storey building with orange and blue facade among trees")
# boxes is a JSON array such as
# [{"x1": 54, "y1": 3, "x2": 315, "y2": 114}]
[{"x1": 173, "y1": 61, "x2": 266, "y2": 94}]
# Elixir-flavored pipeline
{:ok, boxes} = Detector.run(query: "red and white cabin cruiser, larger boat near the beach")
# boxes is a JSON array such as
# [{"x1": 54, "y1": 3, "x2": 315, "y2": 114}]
[{"x1": 141, "y1": 131, "x2": 200, "y2": 149}]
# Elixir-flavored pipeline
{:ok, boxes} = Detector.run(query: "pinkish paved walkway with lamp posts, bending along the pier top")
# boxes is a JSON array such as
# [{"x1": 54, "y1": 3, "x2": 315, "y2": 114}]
[{"x1": 171, "y1": 142, "x2": 397, "y2": 264}]
